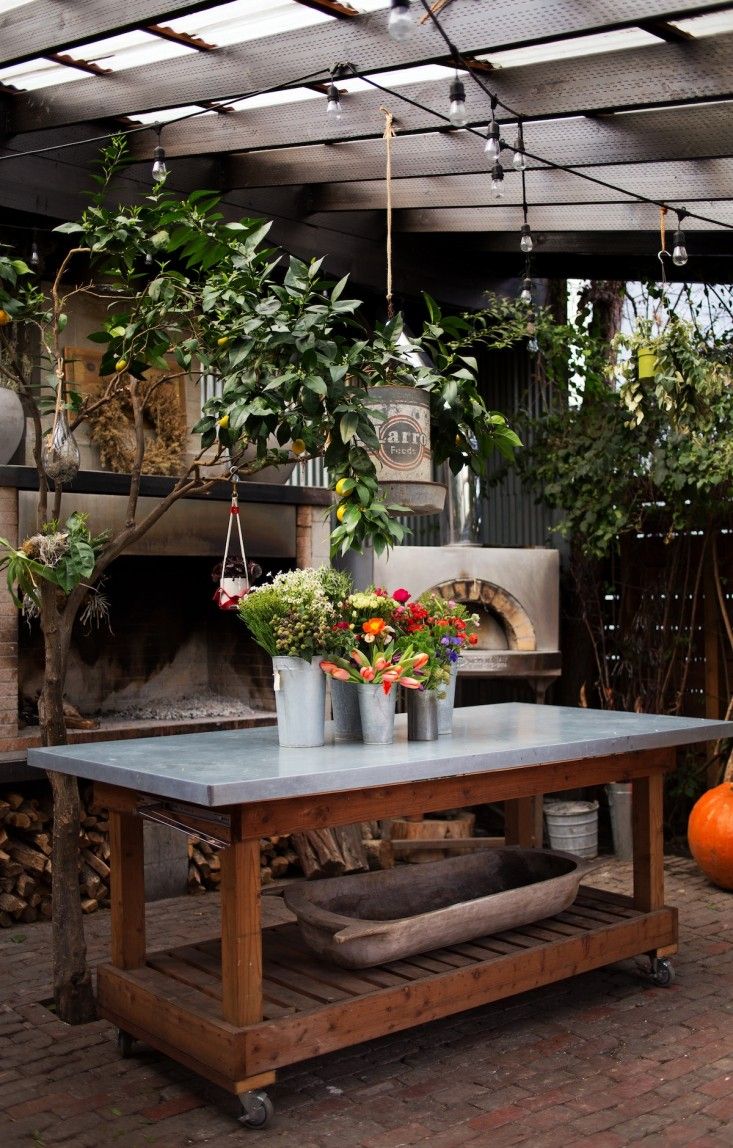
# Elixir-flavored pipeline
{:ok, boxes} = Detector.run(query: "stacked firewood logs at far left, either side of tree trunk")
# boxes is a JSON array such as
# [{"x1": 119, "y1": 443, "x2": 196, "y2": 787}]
[{"x1": 0, "y1": 792, "x2": 109, "y2": 929}]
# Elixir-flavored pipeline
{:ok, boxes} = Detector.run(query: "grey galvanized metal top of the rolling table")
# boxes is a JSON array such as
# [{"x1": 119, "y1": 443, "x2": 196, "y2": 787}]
[{"x1": 28, "y1": 703, "x2": 733, "y2": 807}]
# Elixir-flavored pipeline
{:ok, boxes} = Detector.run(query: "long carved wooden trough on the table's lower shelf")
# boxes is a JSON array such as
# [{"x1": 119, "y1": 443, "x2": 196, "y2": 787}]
[{"x1": 284, "y1": 847, "x2": 600, "y2": 969}]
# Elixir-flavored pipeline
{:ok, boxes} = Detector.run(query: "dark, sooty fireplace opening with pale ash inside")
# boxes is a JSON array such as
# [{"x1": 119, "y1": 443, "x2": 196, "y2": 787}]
[{"x1": 18, "y1": 556, "x2": 293, "y2": 724}]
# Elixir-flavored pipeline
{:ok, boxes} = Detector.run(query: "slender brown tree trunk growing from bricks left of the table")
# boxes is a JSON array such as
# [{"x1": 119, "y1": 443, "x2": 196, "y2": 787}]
[{"x1": 39, "y1": 584, "x2": 96, "y2": 1024}]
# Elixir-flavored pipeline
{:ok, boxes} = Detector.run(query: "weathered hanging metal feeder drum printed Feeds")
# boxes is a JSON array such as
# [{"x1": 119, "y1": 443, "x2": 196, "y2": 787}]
[{"x1": 367, "y1": 387, "x2": 445, "y2": 514}]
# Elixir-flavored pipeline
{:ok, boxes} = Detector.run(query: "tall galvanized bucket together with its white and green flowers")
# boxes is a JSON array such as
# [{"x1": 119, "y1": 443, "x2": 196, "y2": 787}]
[{"x1": 239, "y1": 567, "x2": 351, "y2": 747}]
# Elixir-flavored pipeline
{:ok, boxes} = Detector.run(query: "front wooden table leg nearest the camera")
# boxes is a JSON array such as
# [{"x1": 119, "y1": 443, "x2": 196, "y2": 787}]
[{"x1": 221, "y1": 808, "x2": 263, "y2": 1027}]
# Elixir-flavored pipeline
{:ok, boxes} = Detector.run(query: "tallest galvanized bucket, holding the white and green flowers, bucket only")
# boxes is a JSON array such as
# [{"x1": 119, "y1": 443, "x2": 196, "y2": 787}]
[{"x1": 272, "y1": 654, "x2": 326, "y2": 750}]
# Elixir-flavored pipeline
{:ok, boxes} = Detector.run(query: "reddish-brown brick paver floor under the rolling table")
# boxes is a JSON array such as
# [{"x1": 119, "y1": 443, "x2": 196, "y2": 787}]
[{"x1": 0, "y1": 858, "x2": 733, "y2": 1148}]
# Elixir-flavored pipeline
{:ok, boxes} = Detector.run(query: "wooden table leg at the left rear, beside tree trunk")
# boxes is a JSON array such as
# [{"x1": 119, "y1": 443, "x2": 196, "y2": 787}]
[{"x1": 109, "y1": 809, "x2": 146, "y2": 969}]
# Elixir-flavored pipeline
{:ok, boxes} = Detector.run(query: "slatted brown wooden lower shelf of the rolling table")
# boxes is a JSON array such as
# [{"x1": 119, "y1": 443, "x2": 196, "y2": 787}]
[{"x1": 98, "y1": 887, "x2": 677, "y2": 1092}]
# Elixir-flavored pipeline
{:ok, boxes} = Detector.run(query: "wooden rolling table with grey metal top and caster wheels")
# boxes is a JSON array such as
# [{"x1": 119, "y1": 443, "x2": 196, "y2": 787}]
[{"x1": 29, "y1": 704, "x2": 733, "y2": 1126}]
